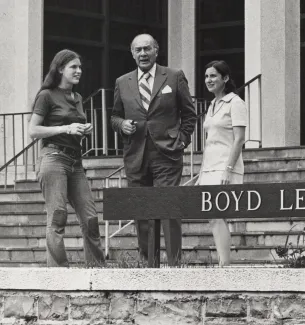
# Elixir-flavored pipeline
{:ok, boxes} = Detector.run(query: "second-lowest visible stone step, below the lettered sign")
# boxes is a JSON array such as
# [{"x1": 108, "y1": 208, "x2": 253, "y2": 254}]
[{"x1": 0, "y1": 231, "x2": 304, "y2": 251}]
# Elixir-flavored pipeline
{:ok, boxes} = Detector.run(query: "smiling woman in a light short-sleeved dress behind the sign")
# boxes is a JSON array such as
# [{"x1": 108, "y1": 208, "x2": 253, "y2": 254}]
[{"x1": 196, "y1": 61, "x2": 248, "y2": 267}]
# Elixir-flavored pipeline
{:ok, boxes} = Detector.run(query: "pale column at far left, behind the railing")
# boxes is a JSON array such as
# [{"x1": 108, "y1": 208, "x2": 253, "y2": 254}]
[{"x1": 0, "y1": 0, "x2": 43, "y2": 164}]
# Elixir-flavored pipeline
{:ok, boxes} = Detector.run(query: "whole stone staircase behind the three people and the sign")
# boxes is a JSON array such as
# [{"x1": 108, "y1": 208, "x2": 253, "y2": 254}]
[{"x1": 0, "y1": 147, "x2": 305, "y2": 266}]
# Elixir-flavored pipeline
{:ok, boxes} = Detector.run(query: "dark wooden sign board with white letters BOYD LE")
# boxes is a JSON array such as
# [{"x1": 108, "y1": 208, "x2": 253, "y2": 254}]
[{"x1": 104, "y1": 183, "x2": 305, "y2": 220}]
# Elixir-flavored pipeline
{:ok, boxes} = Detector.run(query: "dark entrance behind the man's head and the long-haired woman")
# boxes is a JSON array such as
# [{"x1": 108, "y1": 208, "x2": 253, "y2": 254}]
[{"x1": 43, "y1": 0, "x2": 168, "y2": 98}]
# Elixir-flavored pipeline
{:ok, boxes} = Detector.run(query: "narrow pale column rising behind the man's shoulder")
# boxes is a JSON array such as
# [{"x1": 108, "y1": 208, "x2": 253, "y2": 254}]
[{"x1": 168, "y1": 0, "x2": 195, "y2": 96}]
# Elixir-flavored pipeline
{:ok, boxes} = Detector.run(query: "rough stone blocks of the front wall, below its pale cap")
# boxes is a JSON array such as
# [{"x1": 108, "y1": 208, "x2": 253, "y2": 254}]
[{"x1": 0, "y1": 290, "x2": 305, "y2": 325}]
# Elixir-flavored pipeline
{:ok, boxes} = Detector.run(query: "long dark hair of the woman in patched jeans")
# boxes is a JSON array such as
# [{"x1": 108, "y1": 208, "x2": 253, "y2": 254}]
[{"x1": 32, "y1": 49, "x2": 81, "y2": 108}]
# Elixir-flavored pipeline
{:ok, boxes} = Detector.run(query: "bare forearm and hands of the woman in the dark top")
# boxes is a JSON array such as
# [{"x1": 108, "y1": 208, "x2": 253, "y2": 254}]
[{"x1": 29, "y1": 113, "x2": 87, "y2": 139}]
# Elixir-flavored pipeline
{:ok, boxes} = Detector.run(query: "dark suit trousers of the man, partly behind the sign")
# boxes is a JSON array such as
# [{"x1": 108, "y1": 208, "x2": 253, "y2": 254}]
[{"x1": 127, "y1": 136, "x2": 183, "y2": 266}]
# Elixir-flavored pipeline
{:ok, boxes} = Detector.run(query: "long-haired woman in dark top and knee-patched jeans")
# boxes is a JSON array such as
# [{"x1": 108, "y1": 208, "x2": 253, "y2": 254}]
[{"x1": 29, "y1": 50, "x2": 104, "y2": 267}]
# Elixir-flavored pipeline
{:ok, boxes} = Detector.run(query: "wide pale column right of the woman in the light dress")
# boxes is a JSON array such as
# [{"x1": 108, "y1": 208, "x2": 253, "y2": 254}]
[{"x1": 245, "y1": 0, "x2": 300, "y2": 147}]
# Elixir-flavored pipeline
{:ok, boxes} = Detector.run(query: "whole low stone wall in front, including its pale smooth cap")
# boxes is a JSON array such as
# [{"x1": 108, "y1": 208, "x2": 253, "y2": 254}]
[{"x1": 0, "y1": 268, "x2": 305, "y2": 325}]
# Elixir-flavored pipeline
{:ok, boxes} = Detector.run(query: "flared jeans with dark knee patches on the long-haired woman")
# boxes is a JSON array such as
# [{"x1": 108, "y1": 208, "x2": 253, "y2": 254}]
[{"x1": 37, "y1": 147, "x2": 104, "y2": 267}]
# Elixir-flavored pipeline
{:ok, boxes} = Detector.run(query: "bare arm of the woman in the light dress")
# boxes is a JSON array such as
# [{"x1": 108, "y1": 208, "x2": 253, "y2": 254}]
[{"x1": 221, "y1": 126, "x2": 246, "y2": 184}]
